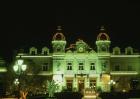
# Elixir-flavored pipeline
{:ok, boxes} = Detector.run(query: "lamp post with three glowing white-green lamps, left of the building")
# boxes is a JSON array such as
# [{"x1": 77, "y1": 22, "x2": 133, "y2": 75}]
[{"x1": 13, "y1": 56, "x2": 27, "y2": 99}]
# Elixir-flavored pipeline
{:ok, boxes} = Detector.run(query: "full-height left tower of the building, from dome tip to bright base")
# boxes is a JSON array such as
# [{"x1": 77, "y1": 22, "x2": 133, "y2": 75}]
[{"x1": 52, "y1": 26, "x2": 66, "y2": 91}]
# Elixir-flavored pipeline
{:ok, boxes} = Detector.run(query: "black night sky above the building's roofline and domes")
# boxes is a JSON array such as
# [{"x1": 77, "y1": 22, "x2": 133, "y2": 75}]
[{"x1": 0, "y1": 0, "x2": 140, "y2": 60}]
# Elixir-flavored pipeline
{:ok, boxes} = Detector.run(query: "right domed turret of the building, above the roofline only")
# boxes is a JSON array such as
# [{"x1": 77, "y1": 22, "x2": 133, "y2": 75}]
[{"x1": 96, "y1": 26, "x2": 111, "y2": 53}]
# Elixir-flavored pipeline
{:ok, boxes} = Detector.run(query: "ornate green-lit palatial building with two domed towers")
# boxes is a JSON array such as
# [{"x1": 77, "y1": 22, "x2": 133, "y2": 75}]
[{"x1": 16, "y1": 27, "x2": 140, "y2": 92}]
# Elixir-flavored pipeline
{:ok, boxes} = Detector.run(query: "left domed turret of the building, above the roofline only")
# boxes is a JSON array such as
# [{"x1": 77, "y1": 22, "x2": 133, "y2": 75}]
[{"x1": 52, "y1": 26, "x2": 66, "y2": 53}]
